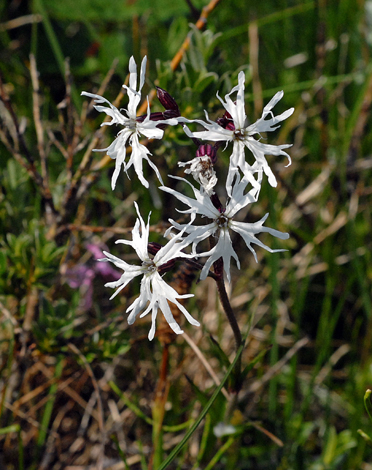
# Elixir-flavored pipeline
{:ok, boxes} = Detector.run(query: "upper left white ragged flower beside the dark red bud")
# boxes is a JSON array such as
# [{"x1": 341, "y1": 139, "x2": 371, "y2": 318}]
[{"x1": 81, "y1": 57, "x2": 178, "y2": 189}]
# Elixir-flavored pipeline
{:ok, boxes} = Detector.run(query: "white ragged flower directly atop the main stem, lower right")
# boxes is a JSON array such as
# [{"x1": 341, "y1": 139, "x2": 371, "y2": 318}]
[{"x1": 160, "y1": 172, "x2": 289, "y2": 282}]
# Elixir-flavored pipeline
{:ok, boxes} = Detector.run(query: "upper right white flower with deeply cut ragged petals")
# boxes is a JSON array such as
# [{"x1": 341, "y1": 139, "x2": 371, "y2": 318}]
[{"x1": 184, "y1": 72, "x2": 294, "y2": 196}]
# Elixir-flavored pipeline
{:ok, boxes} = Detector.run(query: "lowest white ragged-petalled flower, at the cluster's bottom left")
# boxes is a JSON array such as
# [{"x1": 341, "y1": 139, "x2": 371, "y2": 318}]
[{"x1": 100, "y1": 202, "x2": 199, "y2": 341}]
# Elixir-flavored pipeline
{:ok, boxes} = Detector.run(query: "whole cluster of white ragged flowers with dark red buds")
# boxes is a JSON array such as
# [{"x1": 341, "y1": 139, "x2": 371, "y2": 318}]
[{"x1": 82, "y1": 57, "x2": 293, "y2": 340}]
